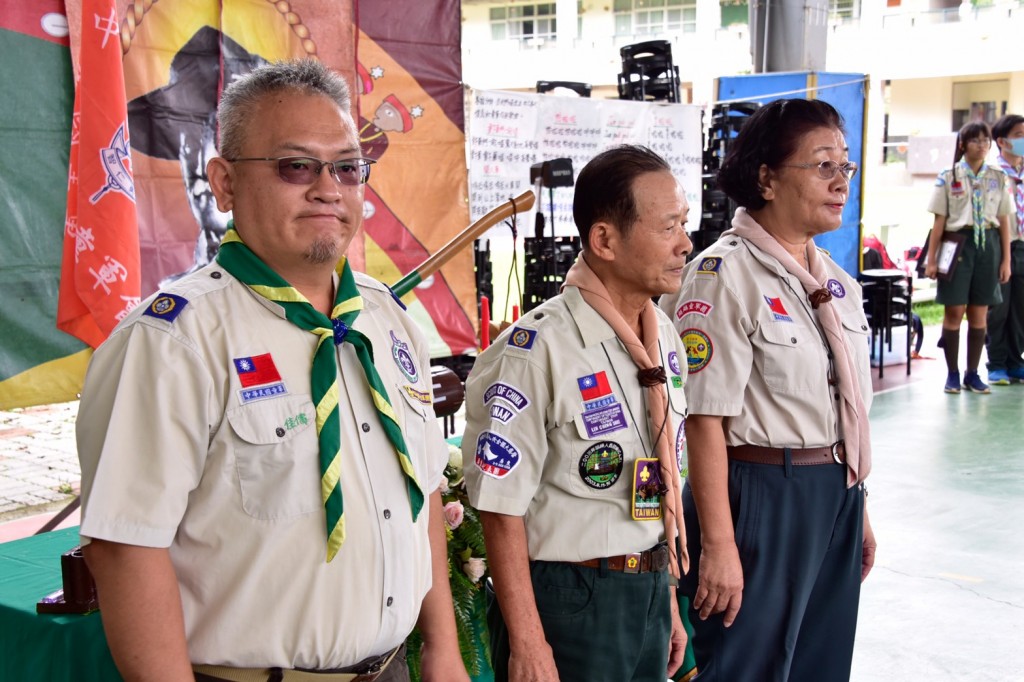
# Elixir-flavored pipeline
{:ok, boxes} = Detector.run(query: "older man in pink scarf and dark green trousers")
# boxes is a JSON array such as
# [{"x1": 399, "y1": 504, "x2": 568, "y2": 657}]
[{"x1": 463, "y1": 146, "x2": 692, "y2": 682}]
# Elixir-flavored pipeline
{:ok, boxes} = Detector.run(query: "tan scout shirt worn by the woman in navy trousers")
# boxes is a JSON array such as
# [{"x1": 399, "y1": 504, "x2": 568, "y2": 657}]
[{"x1": 660, "y1": 236, "x2": 871, "y2": 447}]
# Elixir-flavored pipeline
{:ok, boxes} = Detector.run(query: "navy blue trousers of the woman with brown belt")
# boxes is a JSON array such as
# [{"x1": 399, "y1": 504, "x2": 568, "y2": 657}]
[{"x1": 681, "y1": 450, "x2": 864, "y2": 682}]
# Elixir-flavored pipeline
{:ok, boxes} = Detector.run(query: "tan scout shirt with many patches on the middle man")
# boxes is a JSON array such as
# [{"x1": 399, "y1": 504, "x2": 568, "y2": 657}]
[{"x1": 462, "y1": 287, "x2": 686, "y2": 561}]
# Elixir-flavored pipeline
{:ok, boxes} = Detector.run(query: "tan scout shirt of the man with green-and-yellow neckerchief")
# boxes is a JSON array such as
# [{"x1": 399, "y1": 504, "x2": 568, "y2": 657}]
[{"x1": 78, "y1": 264, "x2": 447, "y2": 669}]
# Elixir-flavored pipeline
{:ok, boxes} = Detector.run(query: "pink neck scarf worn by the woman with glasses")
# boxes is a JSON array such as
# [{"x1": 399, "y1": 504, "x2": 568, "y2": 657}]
[{"x1": 724, "y1": 208, "x2": 871, "y2": 486}]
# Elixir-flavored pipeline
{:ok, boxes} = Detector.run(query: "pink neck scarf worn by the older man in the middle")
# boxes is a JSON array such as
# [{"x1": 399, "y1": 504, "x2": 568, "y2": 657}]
[{"x1": 565, "y1": 255, "x2": 690, "y2": 579}]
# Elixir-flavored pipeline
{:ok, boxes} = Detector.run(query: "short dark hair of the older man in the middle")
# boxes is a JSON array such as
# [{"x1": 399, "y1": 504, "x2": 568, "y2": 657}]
[{"x1": 572, "y1": 144, "x2": 672, "y2": 249}]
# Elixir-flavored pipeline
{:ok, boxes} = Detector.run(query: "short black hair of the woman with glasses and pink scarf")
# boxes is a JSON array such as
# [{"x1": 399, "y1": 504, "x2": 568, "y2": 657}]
[{"x1": 718, "y1": 99, "x2": 846, "y2": 211}]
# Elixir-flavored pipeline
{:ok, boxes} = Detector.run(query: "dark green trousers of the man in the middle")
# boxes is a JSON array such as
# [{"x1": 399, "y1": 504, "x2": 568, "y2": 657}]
[{"x1": 487, "y1": 561, "x2": 672, "y2": 682}]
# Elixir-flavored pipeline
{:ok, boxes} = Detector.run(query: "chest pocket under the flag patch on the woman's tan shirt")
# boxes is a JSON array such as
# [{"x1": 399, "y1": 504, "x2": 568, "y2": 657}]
[{"x1": 753, "y1": 322, "x2": 825, "y2": 394}]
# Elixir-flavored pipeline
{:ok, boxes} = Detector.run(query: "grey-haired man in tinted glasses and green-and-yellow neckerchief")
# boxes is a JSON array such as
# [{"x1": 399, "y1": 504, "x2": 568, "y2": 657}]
[{"x1": 78, "y1": 60, "x2": 468, "y2": 682}]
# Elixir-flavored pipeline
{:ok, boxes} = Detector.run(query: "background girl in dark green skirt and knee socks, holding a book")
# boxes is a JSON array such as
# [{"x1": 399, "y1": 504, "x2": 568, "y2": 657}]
[{"x1": 925, "y1": 122, "x2": 1014, "y2": 393}]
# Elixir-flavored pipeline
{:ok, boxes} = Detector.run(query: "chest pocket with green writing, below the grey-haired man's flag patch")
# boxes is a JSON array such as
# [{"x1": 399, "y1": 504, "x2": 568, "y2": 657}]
[{"x1": 227, "y1": 395, "x2": 323, "y2": 521}]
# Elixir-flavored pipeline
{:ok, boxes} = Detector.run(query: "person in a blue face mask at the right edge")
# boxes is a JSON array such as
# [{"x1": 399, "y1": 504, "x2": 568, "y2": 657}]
[{"x1": 986, "y1": 114, "x2": 1024, "y2": 386}]
